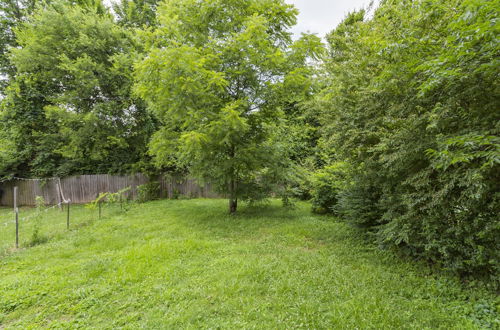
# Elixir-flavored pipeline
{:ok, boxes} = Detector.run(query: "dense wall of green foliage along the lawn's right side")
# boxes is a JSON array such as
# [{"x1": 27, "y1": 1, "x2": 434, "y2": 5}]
[{"x1": 321, "y1": 0, "x2": 500, "y2": 284}]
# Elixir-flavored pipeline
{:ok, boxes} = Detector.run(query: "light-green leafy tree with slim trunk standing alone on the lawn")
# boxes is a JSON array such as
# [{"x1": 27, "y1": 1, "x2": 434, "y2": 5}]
[{"x1": 135, "y1": 0, "x2": 321, "y2": 213}]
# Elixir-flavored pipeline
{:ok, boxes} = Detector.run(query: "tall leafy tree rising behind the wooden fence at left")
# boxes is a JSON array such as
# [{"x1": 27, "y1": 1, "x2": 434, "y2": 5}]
[{"x1": 2, "y1": 0, "x2": 155, "y2": 176}]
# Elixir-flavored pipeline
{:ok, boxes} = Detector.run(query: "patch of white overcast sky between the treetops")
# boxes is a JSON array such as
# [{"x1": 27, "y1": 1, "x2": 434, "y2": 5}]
[{"x1": 285, "y1": 0, "x2": 378, "y2": 37}]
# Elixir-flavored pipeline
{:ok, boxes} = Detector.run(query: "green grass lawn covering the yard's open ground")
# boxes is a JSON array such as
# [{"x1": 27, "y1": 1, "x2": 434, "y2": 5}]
[{"x1": 0, "y1": 199, "x2": 499, "y2": 329}]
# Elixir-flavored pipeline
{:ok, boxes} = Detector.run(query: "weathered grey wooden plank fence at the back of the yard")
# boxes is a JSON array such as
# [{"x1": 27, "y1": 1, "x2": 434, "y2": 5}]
[{"x1": 0, "y1": 174, "x2": 218, "y2": 206}]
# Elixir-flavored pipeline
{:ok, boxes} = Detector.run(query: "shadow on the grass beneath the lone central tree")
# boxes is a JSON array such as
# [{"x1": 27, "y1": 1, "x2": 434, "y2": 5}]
[{"x1": 156, "y1": 199, "x2": 368, "y2": 249}]
